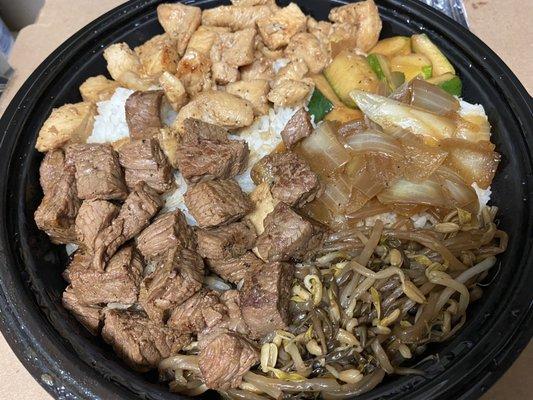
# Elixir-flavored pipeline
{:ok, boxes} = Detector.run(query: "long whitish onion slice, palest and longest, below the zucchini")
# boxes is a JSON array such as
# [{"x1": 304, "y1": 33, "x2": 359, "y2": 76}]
[{"x1": 350, "y1": 90, "x2": 456, "y2": 144}]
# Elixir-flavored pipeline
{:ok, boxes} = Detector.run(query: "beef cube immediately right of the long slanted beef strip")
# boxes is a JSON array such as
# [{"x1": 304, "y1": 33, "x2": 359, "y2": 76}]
[{"x1": 136, "y1": 210, "x2": 196, "y2": 260}]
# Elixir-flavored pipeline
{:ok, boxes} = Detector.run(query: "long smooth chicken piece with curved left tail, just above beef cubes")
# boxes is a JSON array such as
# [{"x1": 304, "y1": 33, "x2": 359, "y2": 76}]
[{"x1": 174, "y1": 91, "x2": 254, "y2": 131}]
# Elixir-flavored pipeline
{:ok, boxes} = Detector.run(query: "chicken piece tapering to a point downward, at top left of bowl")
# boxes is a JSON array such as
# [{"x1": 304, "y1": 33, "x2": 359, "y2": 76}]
[{"x1": 157, "y1": 3, "x2": 202, "y2": 56}]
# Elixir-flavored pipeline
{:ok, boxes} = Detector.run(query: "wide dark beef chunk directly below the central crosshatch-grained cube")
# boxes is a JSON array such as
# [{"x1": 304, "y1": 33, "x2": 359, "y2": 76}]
[{"x1": 196, "y1": 221, "x2": 256, "y2": 259}]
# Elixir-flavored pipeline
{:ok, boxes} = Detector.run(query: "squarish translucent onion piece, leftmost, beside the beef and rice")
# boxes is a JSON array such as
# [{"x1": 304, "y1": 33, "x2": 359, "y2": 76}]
[{"x1": 295, "y1": 121, "x2": 350, "y2": 177}]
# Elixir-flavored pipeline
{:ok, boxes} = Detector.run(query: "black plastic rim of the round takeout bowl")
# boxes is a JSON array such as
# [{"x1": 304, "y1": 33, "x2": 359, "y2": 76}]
[{"x1": 0, "y1": 0, "x2": 533, "y2": 400}]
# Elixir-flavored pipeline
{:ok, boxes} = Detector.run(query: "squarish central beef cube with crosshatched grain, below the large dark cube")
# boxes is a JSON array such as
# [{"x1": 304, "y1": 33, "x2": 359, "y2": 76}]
[{"x1": 184, "y1": 179, "x2": 253, "y2": 228}]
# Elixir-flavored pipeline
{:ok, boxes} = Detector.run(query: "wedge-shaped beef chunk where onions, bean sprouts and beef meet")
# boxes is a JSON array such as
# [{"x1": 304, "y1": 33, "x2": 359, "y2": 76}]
[{"x1": 255, "y1": 203, "x2": 323, "y2": 261}]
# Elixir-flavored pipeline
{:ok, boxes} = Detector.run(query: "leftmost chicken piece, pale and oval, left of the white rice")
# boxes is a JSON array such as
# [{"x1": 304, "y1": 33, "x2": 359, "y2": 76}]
[{"x1": 35, "y1": 101, "x2": 96, "y2": 152}]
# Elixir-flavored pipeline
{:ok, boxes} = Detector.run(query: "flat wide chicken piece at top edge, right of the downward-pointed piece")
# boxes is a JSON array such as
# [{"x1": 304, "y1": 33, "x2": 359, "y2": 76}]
[{"x1": 202, "y1": 6, "x2": 272, "y2": 31}]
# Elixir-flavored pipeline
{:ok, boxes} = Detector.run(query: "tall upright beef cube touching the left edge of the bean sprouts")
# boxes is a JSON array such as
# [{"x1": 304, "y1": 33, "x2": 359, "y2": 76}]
[{"x1": 240, "y1": 262, "x2": 294, "y2": 339}]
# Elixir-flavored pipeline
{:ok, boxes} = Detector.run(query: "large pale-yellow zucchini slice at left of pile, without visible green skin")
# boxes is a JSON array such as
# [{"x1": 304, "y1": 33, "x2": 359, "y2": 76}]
[{"x1": 324, "y1": 50, "x2": 379, "y2": 108}]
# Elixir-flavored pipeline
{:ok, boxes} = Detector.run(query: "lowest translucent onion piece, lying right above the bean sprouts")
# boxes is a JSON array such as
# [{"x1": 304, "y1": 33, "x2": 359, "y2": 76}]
[{"x1": 378, "y1": 179, "x2": 448, "y2": 207}]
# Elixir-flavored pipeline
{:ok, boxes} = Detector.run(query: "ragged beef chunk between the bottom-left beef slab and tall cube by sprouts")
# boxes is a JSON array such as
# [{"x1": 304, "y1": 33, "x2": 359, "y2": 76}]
[{"x1": 167, "y1": 288, "x2": 228, "y2": 333}]
